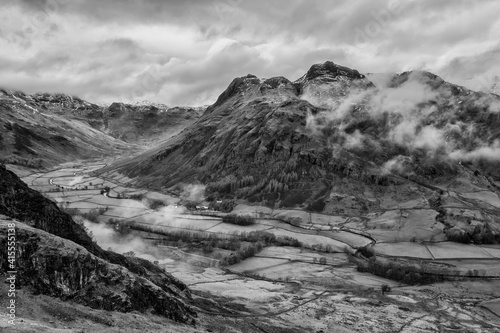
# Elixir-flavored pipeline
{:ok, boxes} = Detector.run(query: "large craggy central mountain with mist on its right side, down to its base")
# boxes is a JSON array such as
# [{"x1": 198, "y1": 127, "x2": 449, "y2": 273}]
[{"x1": 109, "y1": 62, "x2": 500, "y2": 239}]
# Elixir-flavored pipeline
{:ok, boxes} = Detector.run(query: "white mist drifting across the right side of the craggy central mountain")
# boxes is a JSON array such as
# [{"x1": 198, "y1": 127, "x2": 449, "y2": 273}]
[{"x1": 301, "y1": 71, "x2": 500, "y2": 170}]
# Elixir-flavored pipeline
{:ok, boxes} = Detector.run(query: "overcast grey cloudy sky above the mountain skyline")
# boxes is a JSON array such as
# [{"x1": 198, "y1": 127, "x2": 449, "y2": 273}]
[{"x1": 0, "y1": 0, "x2": 500, "y2": 105}]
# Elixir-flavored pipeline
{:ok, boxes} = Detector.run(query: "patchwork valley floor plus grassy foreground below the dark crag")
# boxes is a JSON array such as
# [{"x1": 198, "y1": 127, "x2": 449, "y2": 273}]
[{"x1": 0, "y1": 161, "x2": 500, "y2": 332}]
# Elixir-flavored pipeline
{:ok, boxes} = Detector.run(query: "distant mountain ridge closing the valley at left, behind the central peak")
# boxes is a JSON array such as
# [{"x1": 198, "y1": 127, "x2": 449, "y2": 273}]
[{"x1": 0, "y1": 89, "x2": 204, "y2": 167}]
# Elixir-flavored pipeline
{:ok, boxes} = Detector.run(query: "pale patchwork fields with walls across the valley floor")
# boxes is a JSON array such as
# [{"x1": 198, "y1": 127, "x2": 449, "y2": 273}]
[{"x1": 9, "y1": 163, "x2": 500, "y2": 332}]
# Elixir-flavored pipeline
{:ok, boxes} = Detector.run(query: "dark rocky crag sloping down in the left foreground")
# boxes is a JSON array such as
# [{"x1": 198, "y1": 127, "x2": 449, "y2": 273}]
[{"x1": 0, "y1": 165, "x2": 196, "y2": 322}]
